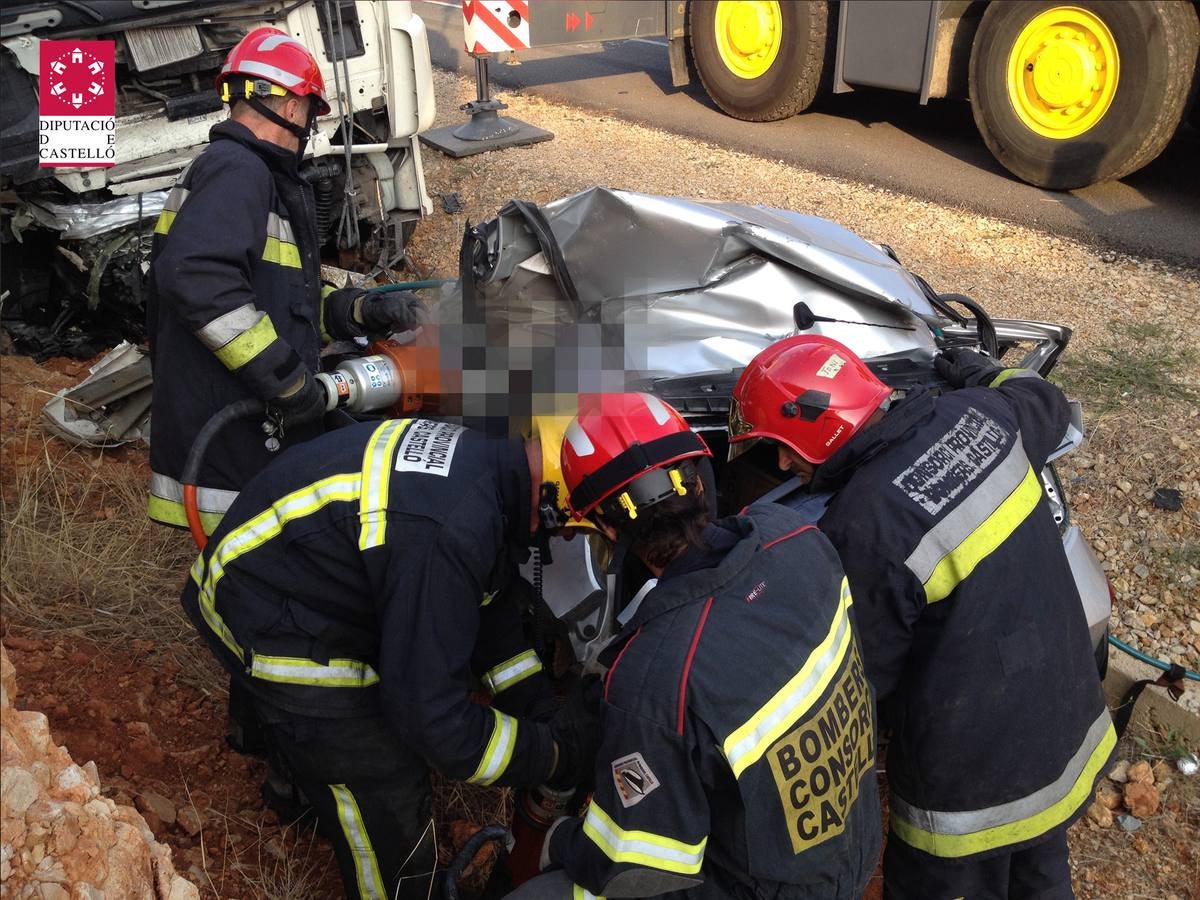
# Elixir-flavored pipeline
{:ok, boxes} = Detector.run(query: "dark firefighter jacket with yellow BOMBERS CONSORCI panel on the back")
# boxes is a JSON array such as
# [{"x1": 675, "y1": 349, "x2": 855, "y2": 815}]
[{"x1": 548, "y1": 504, "x2": 881, "y2": 900}]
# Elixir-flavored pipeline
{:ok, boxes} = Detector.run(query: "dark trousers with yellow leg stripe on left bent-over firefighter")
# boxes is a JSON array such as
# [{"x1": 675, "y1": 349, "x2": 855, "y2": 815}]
[{"x1": 257, "y1": 703, "x2": 437, "y2": 900}]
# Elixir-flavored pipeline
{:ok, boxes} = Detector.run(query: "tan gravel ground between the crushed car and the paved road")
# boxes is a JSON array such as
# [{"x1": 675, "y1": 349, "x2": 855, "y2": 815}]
[{"x1": 413, "y1": 71, "x2": 1200, "y2": 670}]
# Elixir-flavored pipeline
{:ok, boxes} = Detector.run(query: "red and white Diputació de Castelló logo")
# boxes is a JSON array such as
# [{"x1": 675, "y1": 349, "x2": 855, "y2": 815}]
[{"x1": 38, "y1": 41, "x2": 116, "y2": 168}]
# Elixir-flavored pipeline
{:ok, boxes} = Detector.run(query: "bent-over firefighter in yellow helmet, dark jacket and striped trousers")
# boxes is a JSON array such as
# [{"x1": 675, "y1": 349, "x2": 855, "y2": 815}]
[{"x1": 182, "y1": 418, "x2": 596, "y2": 900}]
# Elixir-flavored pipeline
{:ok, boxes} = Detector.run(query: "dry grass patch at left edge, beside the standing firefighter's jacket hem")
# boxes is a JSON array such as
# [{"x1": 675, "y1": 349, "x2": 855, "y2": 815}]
[{"x1": 0, "y1": 440, "x2": 196, "y2": 643}]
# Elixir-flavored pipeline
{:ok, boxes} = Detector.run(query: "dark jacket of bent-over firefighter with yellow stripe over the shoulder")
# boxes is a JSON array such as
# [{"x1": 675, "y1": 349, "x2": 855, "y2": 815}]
[{"x1": 182, "y1": 419, "x2": 553, "y2": 785}]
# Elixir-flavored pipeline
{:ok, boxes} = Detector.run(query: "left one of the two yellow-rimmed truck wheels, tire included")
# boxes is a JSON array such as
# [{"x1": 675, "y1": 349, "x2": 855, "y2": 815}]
[{"x1": 688, "y1": 0, "x2": 833, "y2": 122}]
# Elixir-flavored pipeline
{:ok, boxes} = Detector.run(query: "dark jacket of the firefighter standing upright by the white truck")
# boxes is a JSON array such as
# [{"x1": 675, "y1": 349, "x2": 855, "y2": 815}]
[{"x1": 148, "y1": 121, "x2": 322, "y2": 532}]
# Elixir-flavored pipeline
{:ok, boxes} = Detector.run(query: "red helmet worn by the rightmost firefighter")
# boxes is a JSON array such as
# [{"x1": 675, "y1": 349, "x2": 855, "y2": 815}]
[{"x1": 730, "y1": 335, "x2": 892, "y2": 466}]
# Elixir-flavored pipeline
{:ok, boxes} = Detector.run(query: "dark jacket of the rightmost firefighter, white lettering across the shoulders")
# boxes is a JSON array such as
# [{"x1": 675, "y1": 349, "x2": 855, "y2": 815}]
[{"x1": 812, "y1": 370, "x2": 1116, "y2": 857}]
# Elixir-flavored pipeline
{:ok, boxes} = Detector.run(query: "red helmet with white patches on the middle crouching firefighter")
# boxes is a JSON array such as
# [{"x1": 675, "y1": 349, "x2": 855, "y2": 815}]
[{"x1": 563, "y1": 394, "x2": 713, "y2": 518}]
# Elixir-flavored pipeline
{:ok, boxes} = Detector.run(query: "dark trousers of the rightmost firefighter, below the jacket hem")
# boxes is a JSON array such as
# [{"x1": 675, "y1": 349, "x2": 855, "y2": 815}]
[{"x1": 883, "y1": 828, "x2": 1075, "y2": 900}]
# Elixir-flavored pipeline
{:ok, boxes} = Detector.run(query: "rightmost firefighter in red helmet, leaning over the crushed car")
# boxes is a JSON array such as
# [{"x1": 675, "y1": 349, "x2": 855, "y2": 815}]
[{"x1": 730, "y1": 336, "x2": 1116, "y2": 900}]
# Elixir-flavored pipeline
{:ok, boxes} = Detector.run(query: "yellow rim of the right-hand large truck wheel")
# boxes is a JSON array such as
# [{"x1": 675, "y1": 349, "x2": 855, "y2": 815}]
[{"x1": 1008, "y1": 6, "x2": 1121, "y2": 140}]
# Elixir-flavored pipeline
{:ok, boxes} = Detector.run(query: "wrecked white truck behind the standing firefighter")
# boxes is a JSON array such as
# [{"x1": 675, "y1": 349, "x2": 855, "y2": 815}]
[{"x1": 0, "y1": 0, "x2": 434, "y2": 356}]
